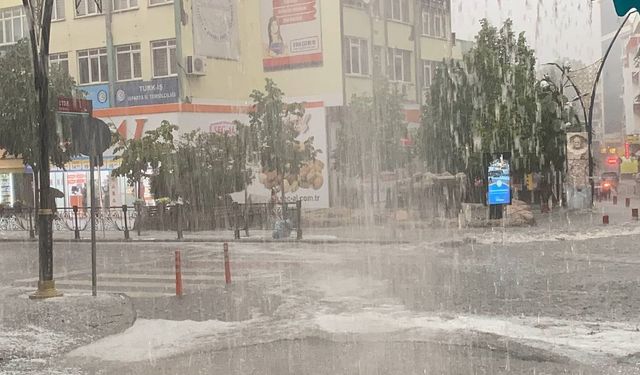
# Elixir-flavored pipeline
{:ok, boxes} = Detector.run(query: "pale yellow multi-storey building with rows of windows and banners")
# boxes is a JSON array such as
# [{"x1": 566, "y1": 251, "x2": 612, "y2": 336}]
[{"x1": 0, "y1": 0, "x2": 461, "y2": 207}]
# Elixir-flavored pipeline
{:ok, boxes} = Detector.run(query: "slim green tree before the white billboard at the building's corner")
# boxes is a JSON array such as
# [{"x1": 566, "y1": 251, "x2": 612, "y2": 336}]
[{"x1": 249, "y1": 78, "x2": 321, "y2": 204}]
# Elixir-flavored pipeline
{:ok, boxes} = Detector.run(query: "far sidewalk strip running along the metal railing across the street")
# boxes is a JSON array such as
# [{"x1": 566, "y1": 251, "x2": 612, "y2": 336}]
[{"x1": 0, "y1": 200, "x2": 640, "y2": 244}]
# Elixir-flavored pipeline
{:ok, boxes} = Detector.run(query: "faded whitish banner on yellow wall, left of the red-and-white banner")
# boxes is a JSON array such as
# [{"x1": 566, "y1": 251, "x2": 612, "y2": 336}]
[{"x1": 192, "y1": 0, "x2": 240, "y2": 60}]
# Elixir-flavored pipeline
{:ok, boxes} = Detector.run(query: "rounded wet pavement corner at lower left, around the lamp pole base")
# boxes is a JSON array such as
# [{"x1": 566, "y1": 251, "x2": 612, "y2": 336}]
[{"x1": 0, "y1": 288, "x2": 136, "y2": 366}]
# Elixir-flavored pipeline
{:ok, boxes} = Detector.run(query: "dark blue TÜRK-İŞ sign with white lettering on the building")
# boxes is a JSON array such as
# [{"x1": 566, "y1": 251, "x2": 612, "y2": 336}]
[{"x1": 115, "y1": 77, "x2": 179, "y2": 107}]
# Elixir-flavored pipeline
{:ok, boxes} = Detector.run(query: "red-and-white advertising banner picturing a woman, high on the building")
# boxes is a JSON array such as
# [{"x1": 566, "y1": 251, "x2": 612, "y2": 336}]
[{"x1": 261, "y1": 0, "x2": 323, "y2": 72}]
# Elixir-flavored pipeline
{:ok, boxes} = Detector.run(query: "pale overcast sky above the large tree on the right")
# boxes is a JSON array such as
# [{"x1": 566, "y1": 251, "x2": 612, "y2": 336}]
[{"x1": 451, "y1": 0, "x2": 600, "y2": 64}]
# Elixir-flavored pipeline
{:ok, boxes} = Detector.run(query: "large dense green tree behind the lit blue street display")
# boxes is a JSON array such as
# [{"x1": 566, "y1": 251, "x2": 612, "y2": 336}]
[{"x1": 420, "y1": 20, "x2": 566, "y2": 176}]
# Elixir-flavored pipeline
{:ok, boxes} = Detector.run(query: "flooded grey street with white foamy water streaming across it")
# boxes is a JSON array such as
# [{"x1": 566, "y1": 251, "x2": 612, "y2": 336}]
[{"x1": 2, "y1": 203, "x2": 640, "y2": 374}]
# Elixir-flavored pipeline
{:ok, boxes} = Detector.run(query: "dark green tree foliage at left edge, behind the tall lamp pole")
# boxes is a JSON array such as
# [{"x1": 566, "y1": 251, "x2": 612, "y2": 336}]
[{"x1": 0, "y1": 39, "x2": 76, "y2": 167}]
